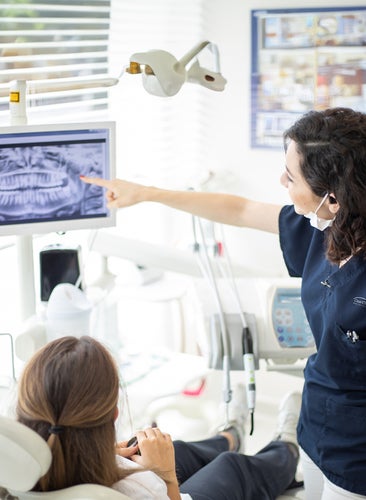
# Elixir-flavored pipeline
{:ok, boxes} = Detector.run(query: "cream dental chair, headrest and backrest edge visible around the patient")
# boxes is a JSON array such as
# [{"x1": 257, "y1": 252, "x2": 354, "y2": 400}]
[{"x1": 0, "y1": 416, "x2": 131, "y2": 500}]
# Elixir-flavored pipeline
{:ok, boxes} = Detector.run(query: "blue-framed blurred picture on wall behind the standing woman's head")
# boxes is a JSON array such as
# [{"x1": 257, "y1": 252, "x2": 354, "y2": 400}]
[{"x1": 251, "y1": 7, "x2": 366, "y2": 148}]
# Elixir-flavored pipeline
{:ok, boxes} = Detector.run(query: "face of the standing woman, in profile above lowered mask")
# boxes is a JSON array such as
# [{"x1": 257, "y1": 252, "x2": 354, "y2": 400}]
[{"x1": 281, "y1": 141, "x2": 329, "y2": 218}]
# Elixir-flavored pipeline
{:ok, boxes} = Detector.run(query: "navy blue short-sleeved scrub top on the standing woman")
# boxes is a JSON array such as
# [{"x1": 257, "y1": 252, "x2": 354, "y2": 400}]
[{"x1": 279, "y1": 206, "x2": 366, "y2": 495}]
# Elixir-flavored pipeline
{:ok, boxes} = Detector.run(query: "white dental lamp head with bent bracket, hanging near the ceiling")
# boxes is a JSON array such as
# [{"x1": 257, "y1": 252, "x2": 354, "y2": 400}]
[{"x1": 126, "y1": 41, "x2": 226, "y2": 97}]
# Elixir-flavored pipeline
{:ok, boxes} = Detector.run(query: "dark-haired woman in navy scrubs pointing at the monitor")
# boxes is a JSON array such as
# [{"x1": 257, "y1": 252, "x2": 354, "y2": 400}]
[{"x1": 83, "y1": 108, "x2": 366, "y2": 500}]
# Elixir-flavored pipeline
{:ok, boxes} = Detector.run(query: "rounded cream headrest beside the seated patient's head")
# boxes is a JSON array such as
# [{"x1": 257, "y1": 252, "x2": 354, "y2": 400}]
[{"x1": 0, "y1": 416, "x2": 52, "y2": 491}]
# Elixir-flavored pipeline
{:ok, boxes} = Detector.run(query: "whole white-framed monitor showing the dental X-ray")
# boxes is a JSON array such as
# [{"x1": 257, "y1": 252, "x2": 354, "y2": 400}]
[{"x1": 0, "y1": 122, "x2": 115, "y2": 235}]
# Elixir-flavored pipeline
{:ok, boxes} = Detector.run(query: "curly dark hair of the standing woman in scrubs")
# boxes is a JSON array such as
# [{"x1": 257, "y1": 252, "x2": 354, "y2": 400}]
[{"x1": 284, "y1": 107, "x2": 366, "y2": 263}]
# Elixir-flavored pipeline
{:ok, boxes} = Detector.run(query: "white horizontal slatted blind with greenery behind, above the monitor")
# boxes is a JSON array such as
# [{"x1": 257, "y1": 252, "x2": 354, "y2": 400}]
[{"x1": 0, "y1": 0, "x2": 110, "y2": 125}]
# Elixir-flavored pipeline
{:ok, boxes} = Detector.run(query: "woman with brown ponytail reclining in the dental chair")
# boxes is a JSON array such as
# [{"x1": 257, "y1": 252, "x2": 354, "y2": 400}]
[{"x1": 17, "y1": 336, "x2": 300, "y2": 500}]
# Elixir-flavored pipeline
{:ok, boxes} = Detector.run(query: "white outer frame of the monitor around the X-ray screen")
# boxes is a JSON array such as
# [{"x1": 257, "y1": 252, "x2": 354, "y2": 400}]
[{"x1": 0, "y1": 121, "x2": 116, "y2": 236}]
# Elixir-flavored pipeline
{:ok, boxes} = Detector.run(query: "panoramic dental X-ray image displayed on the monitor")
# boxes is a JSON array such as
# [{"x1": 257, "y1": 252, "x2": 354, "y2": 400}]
[{"x1": 0, "y1": 142, "x2": 105, "y2": 222}]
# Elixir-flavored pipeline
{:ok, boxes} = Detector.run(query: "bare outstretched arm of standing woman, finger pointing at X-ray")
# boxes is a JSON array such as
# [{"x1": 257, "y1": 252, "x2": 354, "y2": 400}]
[{"x1": 81, "y1": 177, "x2": 281, "y2": 233}]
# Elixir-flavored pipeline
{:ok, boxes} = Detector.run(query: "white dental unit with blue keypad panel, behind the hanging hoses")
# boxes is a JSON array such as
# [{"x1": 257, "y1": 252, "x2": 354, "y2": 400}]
[{"x1": 196, "y1": 277, "x2": 316, "y2": 376}]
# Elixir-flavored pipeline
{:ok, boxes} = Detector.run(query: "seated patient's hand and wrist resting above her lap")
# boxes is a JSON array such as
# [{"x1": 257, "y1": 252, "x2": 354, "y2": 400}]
[{"x1": 131, "y1": 427, "x2": 177, "y2": 483}]
